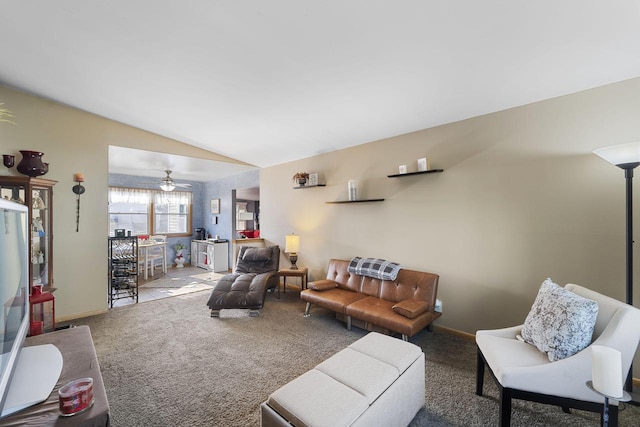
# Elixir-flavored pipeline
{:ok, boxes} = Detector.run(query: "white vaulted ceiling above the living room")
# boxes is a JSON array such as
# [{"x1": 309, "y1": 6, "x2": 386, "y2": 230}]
[{"x1": 0, "y1": 0, "x2": 640, "y2": 176}]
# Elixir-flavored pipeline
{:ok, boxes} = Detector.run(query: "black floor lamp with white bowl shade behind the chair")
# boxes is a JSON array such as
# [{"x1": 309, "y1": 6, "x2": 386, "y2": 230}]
[{"x1": 593, "y1": 142, "x2": 640, "y2": 404}]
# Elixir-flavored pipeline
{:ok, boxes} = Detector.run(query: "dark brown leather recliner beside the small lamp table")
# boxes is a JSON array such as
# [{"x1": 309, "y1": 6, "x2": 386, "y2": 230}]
[{"x1": 207, "y1": 246, "x2": 280, "y2": 317}]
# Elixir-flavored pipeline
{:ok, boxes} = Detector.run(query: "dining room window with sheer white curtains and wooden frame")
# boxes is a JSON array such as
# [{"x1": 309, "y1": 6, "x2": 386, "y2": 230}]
[{"x1": 109, "y1": 187, "x2": 193, "y2": 236}]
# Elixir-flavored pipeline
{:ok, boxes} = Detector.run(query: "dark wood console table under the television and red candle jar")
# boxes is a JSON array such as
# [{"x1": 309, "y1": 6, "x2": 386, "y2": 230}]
[{"x1": 0, "y1": 326, "x2": 109, "y2": 427}]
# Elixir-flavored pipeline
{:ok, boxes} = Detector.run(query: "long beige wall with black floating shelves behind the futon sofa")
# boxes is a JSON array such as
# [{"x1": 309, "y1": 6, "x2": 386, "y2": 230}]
[{"x1": 261, "y1": 79, "x2": 640, "y2": 376}]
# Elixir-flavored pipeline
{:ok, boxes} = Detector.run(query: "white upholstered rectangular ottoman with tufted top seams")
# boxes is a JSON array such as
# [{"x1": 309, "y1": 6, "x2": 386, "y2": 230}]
[{"x1": 261, "y1": 332, "x2": 425, "y2": 427}]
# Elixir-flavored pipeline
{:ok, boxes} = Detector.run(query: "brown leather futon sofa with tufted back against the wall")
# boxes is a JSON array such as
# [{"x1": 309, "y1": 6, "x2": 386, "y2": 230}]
[{"x1": 300, "y1": 259, "x2": 441, "y2": 341}]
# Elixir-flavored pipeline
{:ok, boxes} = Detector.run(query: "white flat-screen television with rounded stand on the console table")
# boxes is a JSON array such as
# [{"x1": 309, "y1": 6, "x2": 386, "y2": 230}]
[{"x1": 0, "y1": 199, "x2": 62, "y2": 418}]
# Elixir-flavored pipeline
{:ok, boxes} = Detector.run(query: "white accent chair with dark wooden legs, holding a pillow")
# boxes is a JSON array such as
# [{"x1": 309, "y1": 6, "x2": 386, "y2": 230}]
[{"x1": 476, "y1": 284, "x2": 640, "y2": 427}]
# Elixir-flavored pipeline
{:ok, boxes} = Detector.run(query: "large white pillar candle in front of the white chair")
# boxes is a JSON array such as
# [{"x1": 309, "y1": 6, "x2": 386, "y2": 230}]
[{"x1": 591, "y1": 345, "x2": 622, "y2": 398}]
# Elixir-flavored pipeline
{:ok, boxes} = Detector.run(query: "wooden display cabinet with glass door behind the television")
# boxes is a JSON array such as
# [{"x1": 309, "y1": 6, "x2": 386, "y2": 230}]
[{"x1": 0, "y1": 176, "x2": 58, "y2": 294}]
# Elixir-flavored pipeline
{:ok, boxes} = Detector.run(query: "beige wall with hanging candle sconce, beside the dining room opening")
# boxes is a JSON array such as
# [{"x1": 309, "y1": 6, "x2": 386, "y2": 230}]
[{"x1": 0, "y1": 86, "x2": 245, "y2": 320}]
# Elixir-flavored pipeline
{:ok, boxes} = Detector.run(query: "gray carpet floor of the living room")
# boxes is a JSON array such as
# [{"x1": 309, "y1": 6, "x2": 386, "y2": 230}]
[{"x1": 71, "y1": 290, "x2": 640, "y2": 427}]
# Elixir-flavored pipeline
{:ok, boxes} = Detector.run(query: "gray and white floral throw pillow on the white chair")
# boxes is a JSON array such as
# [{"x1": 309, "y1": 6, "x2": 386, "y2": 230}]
[{"x1": 522, "y1": 279, "x2": 598, "y2": 362}]
